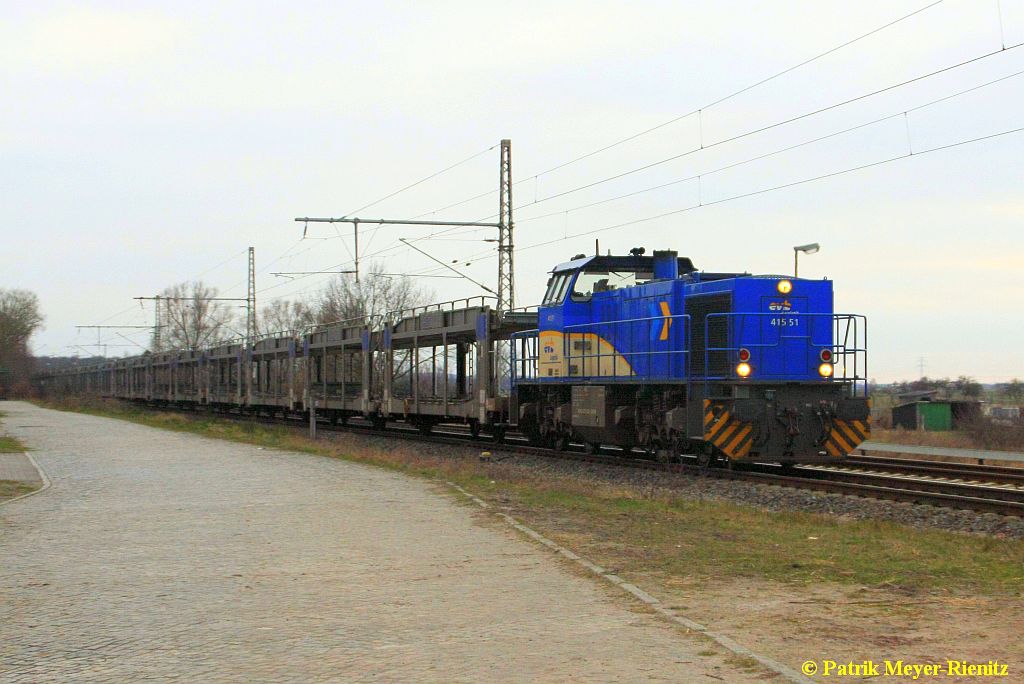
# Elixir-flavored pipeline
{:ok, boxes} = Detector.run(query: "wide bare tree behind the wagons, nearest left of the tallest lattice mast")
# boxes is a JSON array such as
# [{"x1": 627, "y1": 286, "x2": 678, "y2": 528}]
[{"x1": 316, "y1": 262, "x2": 434, "y2": 324}]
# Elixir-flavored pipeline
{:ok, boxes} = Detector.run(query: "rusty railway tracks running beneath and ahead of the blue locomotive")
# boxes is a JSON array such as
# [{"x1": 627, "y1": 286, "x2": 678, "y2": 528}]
[{"x1": 151, "y1": 408, "x2": 1024, "y2": 517}]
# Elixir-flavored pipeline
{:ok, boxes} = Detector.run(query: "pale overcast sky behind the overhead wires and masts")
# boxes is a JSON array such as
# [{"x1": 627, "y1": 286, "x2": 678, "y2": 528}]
[{"x1": 0, "y1": 0, "x2": 1024, "y2": 382}]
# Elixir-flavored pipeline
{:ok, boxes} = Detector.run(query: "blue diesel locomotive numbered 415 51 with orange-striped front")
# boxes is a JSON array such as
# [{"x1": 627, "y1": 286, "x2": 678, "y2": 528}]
[{"x1": 509, "y1": 249, "x2": 870, "y2": 464}]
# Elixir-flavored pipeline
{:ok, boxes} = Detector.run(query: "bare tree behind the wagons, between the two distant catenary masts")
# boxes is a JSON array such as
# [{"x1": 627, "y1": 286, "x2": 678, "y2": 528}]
[{"x1": 161, "y1": 281, "x2": 240, "y2": 350}]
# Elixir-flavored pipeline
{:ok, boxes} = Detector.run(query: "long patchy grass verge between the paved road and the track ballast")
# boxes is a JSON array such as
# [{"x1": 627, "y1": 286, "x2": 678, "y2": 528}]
[{"x1": 36, "y1": 403, "x2": 1024, "y2": 596}]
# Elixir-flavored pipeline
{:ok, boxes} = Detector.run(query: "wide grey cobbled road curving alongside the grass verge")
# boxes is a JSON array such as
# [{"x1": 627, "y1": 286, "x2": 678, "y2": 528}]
[{"x1": 0, "y1": 402, "x2": 753, "y2": 682}]
